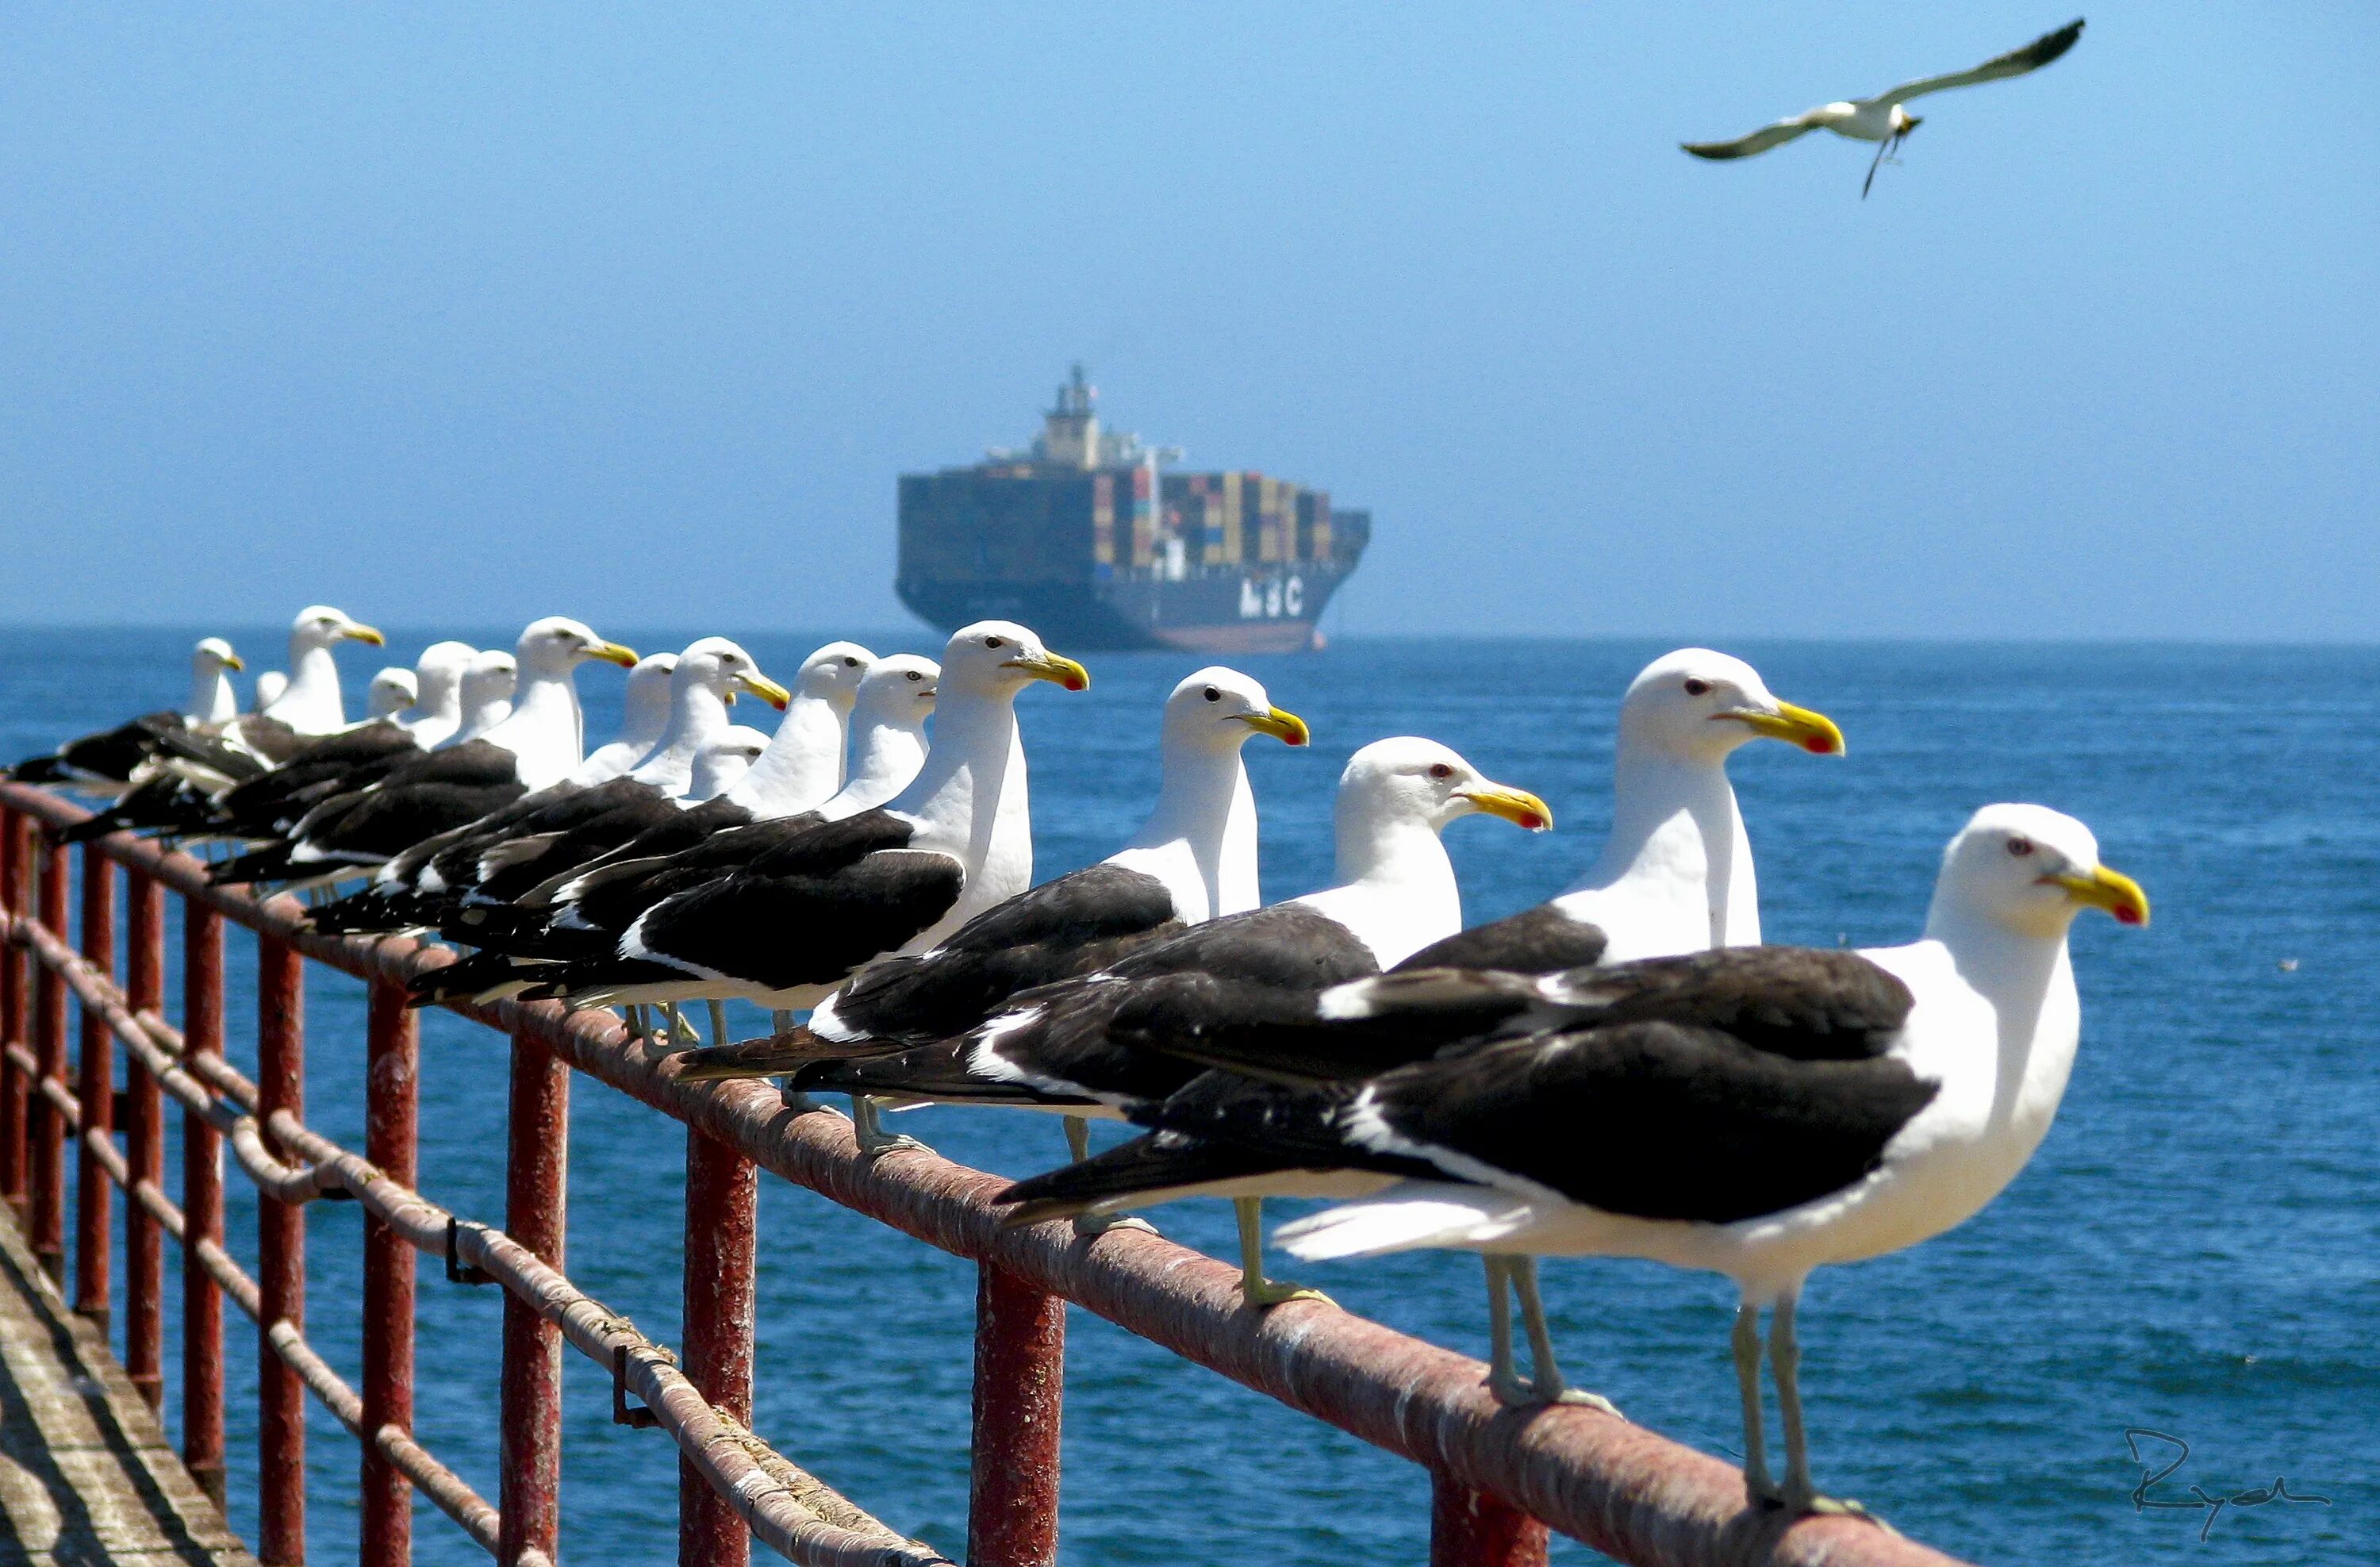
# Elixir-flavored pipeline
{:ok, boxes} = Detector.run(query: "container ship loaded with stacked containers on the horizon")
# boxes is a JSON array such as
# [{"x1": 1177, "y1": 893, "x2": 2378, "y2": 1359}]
[{"x1": 895, "y1": 364, "x2": 1371, "y2": 652}]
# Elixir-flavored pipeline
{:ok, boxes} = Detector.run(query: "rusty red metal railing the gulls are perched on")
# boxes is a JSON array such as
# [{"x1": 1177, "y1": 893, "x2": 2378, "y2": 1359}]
[{"x1": 0, "y1": 784, "x2": 1949, "y2": 1567}]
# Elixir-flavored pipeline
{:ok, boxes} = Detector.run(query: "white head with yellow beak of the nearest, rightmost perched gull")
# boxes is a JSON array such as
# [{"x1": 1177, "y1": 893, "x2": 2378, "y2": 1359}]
[{"x1": 1925, "y1": 805, "x2": 2149, "y2": 939}]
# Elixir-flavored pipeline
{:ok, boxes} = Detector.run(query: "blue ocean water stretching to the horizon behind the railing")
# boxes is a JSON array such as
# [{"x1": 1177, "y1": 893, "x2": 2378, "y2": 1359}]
[{"x1": 0, "y1": 624, "x2": 2380, "y2": 1567}]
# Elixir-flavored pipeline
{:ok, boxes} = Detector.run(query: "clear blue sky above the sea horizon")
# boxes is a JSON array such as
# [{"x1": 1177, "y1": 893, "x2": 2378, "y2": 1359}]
[{"x1": 0, "y1": 0, "x2": 2380, "y2": 638}]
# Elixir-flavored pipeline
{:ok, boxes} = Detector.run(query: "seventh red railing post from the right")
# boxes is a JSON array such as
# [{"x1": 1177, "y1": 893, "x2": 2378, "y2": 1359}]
[{"x1": 181, "y1": 898, "x2": 224, "y2": 1510}]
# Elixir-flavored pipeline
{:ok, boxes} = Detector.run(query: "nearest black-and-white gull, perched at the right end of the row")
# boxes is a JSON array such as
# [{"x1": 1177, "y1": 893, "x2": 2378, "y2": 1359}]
[{"x1": 1228, "y1": 805, "x2": 2149, "y2": 1512}]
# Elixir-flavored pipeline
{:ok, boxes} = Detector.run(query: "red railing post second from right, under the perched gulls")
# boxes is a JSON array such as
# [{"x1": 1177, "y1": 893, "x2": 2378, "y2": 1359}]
[{"x1": 966, "y1": 1262, "x2": 1066, "y2": 1567}]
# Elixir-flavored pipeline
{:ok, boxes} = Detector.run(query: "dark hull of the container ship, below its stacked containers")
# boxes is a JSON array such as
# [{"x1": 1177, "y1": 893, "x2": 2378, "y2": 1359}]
[{"x1": 895, "y1": 562, "x2": 1347, "y2": 652}]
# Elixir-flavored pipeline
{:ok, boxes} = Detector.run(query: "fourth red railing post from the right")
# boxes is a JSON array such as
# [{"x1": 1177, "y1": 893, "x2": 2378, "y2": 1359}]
[{"x1": 495, "y1": 1031, "x2": 571, "y2": 1567}]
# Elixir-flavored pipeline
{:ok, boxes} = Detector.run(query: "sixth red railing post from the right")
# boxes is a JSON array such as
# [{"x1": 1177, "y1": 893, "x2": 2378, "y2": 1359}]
[{"x1": 257, "y1": 936, "x2": 305, "y2": 1567}]
